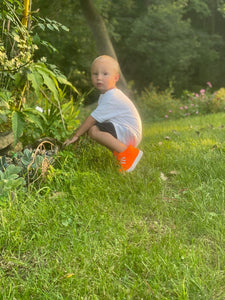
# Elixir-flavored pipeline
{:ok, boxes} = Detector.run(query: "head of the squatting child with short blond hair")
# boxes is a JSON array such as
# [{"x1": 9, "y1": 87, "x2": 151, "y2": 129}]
[{"x1": 91, "y1": 58, "x2": 119, "y2": 94}]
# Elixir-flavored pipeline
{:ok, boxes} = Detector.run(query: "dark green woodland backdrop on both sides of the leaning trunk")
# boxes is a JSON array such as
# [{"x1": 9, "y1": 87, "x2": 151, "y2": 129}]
[{"x1": 33, "y1": 0, "x2": 225, "y2": 94}]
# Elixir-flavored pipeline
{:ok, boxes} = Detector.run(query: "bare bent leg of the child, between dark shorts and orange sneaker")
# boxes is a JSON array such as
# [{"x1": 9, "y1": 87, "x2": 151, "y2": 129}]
[{"x1": 88, "y1": 125, "x2": 127, "y2": 153}]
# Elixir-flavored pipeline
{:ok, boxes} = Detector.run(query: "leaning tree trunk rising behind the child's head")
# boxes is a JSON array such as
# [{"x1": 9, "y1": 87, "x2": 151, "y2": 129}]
[{"x1": 80, "y1": 0, "x2": 128, "y2": 92}]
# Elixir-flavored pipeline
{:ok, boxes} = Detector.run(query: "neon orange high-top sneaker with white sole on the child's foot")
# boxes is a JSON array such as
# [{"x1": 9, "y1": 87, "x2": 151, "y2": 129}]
[{"x1": 117, "y1": 146, "x2": 143, "y2": 172}]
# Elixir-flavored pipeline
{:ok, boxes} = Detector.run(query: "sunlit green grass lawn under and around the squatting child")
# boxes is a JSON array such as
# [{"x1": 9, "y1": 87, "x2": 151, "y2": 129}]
[{"x1": 0, "y1": 114, "x2": 225, "y2": 300}]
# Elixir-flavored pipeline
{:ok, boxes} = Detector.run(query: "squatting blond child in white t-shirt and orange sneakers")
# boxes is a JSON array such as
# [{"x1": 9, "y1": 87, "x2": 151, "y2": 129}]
[{"x1": 64, "y1": 55, "x2": 143, "y2": 172}]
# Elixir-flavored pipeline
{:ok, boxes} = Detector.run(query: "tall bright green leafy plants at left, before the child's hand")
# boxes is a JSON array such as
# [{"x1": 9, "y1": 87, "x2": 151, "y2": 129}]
[{"x1": 0, "y1": 1, "x2": 79, "y2": 143}]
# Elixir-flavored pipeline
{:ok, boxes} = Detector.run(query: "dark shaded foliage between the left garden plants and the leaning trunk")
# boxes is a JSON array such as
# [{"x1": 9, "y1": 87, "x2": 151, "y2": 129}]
[{"x1": 33, "y1": 0, "x2": 98, "y2": 92}]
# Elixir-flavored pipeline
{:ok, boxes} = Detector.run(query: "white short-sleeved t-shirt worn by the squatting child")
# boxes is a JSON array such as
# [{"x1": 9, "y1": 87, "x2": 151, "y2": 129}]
[{"x1": 91, "y1": 88, "x2": 142, "y2": 147}]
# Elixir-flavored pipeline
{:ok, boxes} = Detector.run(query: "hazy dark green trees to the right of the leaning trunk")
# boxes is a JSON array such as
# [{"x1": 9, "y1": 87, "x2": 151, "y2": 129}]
[{"x1": 107, "y1": 0, "x2": 225, "y2": 91}]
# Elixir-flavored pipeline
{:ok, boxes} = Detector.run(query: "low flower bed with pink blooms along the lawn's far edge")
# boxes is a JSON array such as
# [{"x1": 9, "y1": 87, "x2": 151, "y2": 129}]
[{"x1": 137, "y1": 82, "x2": 225, "y2": 121}]
